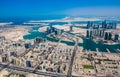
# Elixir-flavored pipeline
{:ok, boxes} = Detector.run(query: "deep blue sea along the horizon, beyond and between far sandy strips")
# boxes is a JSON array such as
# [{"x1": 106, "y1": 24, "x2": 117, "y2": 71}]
[{"x1": 0, "y1": 15, "x2": 120, "y2": 25}]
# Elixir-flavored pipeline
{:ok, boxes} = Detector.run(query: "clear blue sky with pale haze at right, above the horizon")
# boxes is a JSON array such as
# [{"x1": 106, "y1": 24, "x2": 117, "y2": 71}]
[{"x1": 0, "y1": 0, "x2": 120, "y2": 16}]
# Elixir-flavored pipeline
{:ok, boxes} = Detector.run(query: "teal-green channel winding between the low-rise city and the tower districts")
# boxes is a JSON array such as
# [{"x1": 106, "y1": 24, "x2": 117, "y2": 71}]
[{"x1": 23, "y1": 27, "x2": 120, "y2": 53}]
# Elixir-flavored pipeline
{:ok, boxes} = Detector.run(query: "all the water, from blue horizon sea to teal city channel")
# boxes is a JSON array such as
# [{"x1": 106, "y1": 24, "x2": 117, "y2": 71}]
[{"x1": 0, "y1": 16, "x2": 120, "y2": 53}]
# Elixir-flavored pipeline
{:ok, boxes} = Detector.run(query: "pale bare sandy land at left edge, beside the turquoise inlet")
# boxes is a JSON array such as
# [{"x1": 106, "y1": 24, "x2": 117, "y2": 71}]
[{"x1": 0, "y1": 26, "x2": 30, "y2": 41}]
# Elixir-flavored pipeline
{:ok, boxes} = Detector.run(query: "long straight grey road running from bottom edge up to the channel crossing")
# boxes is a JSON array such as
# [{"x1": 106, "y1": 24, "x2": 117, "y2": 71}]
[{"x1": 67, "y1": 38, "x2": 78, "y2": 77}]
